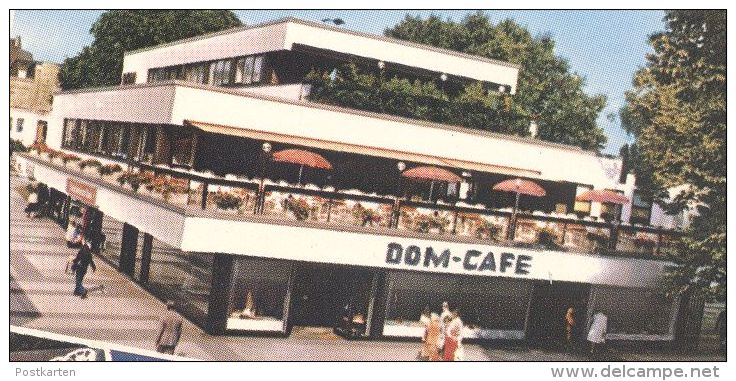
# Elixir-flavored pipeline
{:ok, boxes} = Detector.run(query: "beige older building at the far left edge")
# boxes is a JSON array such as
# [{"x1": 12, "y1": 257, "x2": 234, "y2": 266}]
[{"x1": 10, "y1": 36, "x2": 59, "y2": 145}]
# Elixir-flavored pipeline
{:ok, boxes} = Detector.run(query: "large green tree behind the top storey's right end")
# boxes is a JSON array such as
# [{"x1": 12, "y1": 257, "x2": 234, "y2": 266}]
[{"x1": 385, "y1": 12, "x2": 606, "y2": 149}]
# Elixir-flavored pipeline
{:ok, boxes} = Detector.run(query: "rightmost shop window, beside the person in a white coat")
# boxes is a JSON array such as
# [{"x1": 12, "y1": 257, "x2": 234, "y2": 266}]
[{"x1": 588, "y1": 286, "x2": 677, "y2": 338}]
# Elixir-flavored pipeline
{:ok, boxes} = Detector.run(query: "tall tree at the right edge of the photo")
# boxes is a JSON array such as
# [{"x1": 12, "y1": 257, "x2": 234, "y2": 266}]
[{"x1": 621, "y1": 11, "x2": 727, "y2": 300}]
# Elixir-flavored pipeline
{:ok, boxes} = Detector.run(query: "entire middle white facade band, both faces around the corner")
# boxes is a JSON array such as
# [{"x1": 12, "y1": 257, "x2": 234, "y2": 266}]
[{"x1": 48, "y1": 84, "x2": 626, "y2": 190}]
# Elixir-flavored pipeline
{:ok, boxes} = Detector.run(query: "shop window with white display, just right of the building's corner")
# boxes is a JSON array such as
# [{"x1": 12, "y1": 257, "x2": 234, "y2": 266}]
[{"x1": 226, "y1": 258, "x2": 292, "y2": 331}]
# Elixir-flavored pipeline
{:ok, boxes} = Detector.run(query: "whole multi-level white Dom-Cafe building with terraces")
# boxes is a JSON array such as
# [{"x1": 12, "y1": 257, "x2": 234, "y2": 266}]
[{"x1": 14, "y1": 19, "x2": 700, "y2": 341}]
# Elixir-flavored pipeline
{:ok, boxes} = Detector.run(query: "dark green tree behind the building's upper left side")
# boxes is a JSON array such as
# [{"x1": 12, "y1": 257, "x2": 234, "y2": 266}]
[{"x1": 59, "y1": 10, "x2": 241, "y2": 90}]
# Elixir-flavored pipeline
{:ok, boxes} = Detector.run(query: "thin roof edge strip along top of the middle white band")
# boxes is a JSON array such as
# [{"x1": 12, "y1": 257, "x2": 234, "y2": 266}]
[{"x1": 56, "y1": 80, "x2": 600, "y2": 158}]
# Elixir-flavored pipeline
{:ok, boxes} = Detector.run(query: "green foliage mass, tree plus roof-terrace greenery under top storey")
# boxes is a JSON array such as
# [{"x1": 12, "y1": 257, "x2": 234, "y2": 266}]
[{"x1": 316, "y1": 12, "x2": 606, "y2": 149}]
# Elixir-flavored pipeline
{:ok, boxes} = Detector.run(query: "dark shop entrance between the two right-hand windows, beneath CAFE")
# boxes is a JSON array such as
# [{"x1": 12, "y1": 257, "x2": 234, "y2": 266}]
[{"x1": 527, "y1": 282, "x2": 590, "y2": 348}]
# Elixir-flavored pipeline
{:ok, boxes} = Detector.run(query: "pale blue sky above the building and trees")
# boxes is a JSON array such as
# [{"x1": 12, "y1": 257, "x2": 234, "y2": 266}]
[{"x1": 10, "y1": 10, "x2": 665, "y2": 154}]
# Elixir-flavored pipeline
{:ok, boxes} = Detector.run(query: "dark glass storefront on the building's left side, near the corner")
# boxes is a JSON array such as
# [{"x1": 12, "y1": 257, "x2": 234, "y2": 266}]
[{"x1": 147, "y1": 238, "x2": 213, "y2": 324}]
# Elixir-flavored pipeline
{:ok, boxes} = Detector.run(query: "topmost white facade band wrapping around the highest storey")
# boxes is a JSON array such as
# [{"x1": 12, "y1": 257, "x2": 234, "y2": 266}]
[{"x1": 123, "y1": 19, "x2": 519, "y2": 94}]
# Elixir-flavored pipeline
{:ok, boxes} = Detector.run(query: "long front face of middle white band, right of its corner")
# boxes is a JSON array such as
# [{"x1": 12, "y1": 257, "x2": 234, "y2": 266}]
[{"x1": 172, "y1": 86, "x2": 623, "y2": 190}]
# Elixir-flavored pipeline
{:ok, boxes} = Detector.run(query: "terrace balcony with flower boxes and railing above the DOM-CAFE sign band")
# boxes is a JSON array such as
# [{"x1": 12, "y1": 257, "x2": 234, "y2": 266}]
[{"x1": 18, "y1": 150, "x2": 681, "y2": 260}]
